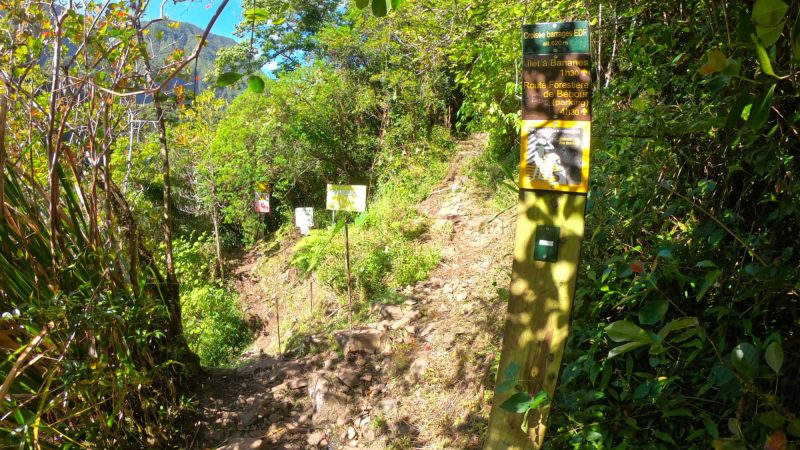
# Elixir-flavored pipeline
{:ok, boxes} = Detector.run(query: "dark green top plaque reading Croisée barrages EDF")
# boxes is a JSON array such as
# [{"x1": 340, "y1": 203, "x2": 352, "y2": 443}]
[{"x1": 522, "y1": 21, "x2": 589, "y2": 55}]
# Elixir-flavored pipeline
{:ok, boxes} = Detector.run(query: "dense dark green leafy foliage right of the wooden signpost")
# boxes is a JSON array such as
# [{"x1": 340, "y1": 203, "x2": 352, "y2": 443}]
[{"x1": 550, "y1": 0, "x2": 800, "y2": 449}]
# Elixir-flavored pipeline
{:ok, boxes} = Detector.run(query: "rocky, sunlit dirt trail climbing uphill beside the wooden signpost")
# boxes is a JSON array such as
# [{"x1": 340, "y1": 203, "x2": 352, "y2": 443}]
[{"x1": 193, "y1": 138, "x2": 514, "y2": 449}]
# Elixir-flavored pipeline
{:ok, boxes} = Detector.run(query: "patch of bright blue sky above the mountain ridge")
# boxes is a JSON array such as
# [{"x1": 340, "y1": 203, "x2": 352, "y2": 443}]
[{"x1": 145, "y1": 0, "x2": 242, "y2": 41}]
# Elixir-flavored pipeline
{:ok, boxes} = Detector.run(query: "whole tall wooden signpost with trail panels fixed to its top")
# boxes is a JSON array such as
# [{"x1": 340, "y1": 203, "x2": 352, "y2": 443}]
[{"x1": 484, "y1": 22, "x2": 591, "y2": 450}]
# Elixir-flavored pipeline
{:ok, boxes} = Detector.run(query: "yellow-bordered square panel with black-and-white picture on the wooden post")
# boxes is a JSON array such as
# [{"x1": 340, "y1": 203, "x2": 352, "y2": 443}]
[{"x1": 519, "y1": 120, "x2": 591, "y2": 193}]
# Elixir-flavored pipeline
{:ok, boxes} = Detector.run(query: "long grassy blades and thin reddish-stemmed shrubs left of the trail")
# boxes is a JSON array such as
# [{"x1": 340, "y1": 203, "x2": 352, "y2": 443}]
[{"x1": 0, "y1": 1, "x2": 212, "y2": 448}]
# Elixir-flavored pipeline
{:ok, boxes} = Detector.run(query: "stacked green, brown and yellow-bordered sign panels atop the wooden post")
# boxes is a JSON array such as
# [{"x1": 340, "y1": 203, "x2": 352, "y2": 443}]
[{"x1": 519, "y1": 22, "x2": 592, "y2": 193}]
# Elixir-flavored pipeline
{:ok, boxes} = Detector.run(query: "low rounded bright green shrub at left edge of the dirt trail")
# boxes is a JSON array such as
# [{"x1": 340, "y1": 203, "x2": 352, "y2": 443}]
[{"x1": 181, "y1": 286, "x2": 251, "y2": 367}]
